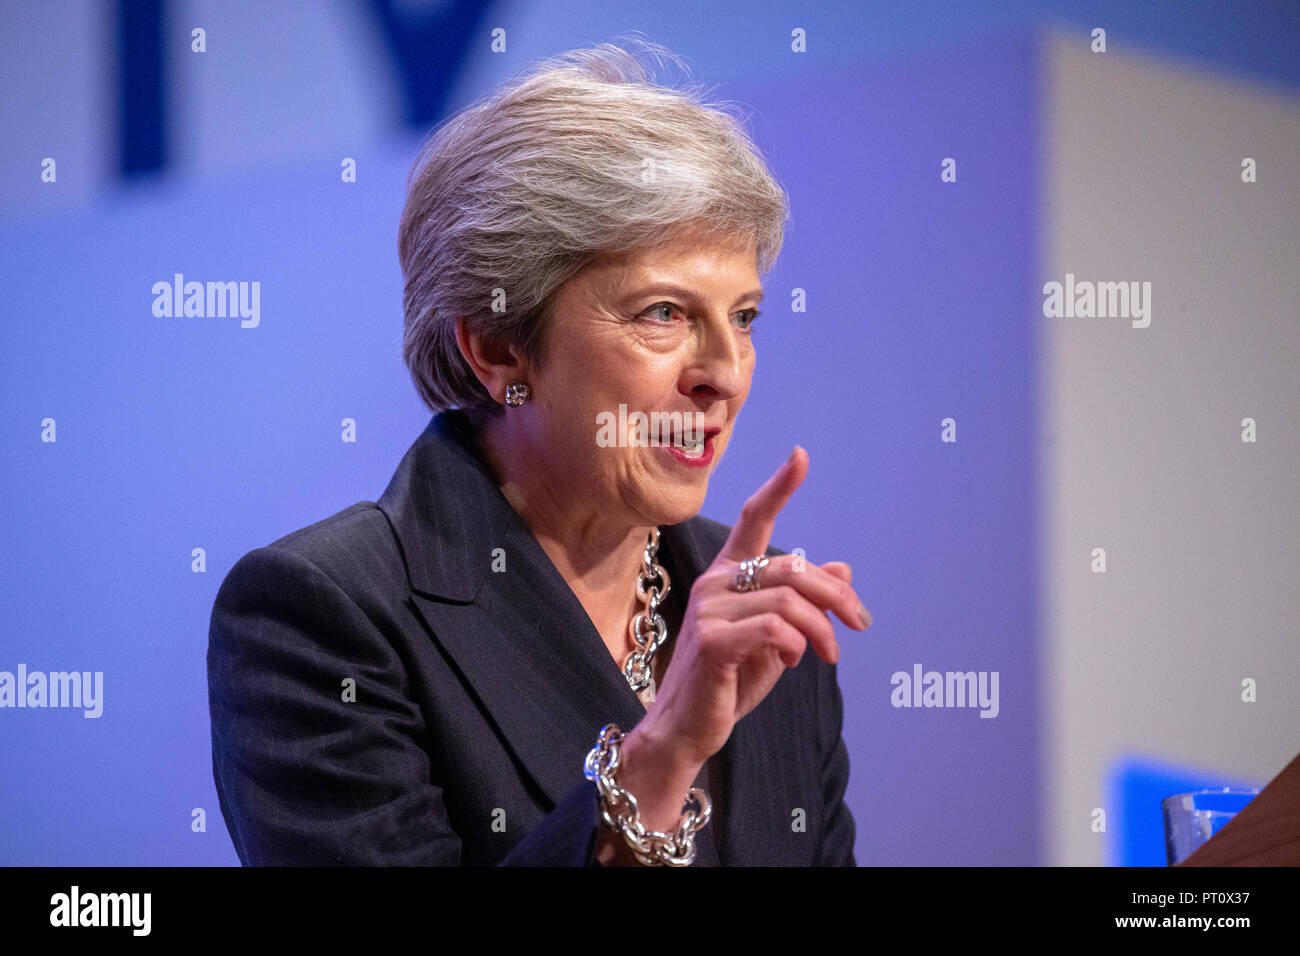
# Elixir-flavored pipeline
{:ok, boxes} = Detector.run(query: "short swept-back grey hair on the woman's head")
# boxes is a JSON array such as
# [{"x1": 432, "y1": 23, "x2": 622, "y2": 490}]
[{"x1": 398, "y1": 39, "x2": 789, "y2": 421}]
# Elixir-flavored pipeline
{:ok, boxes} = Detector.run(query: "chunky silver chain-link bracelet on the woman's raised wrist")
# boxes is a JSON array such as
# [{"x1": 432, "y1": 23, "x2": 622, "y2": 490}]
[{"x1": 584, "y1": 723, "x2": 714, "y2": 866}]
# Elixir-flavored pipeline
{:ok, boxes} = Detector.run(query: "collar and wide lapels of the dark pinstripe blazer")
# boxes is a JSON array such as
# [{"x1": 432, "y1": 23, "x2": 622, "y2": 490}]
[{"x1": 378, "y1": 410, "x2": 727, "y2": 865}]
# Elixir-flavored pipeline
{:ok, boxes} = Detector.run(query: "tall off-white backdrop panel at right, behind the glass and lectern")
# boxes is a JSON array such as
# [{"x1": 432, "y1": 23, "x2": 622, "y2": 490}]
[{"x1": 1041, "y1": 31, "x2": 1300, "y2": 865}]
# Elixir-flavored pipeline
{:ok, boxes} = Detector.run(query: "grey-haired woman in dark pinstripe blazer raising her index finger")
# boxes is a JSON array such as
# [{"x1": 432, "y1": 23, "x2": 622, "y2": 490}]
[{"x1": 208, "y1": 44, "x2": 870, "y2": 865}]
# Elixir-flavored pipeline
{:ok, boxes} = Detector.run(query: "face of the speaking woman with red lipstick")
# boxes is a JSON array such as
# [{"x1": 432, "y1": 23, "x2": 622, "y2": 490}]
[{"x1": 520, "y1": 233, "x2": 763, "y2": 535}]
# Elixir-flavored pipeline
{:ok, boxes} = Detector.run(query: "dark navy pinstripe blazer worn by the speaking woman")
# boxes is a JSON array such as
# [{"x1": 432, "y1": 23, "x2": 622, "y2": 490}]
[{"x1": 208, "y1": 412, "x2": 854, "y2": 866}]
